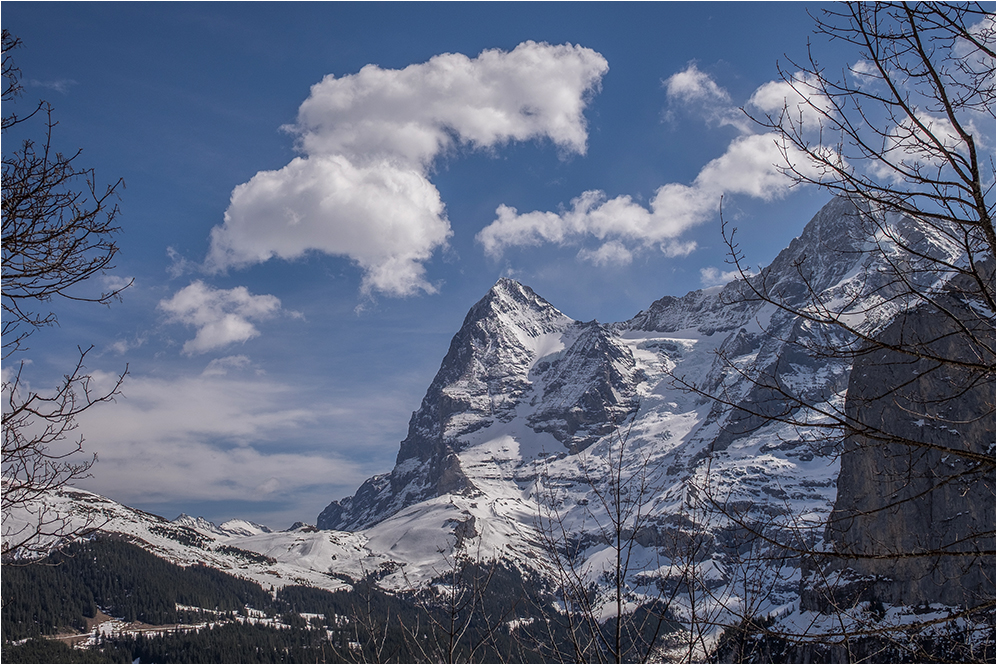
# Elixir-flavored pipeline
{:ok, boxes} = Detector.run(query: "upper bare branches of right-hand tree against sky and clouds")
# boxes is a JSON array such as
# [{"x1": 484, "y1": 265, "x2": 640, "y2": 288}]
[{"x1": 753, "y1": 2, "x2": 995, "y2": 272}]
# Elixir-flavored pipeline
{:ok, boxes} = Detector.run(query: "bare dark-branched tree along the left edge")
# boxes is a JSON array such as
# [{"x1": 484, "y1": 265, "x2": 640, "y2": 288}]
[{"x1": 2, "y1": 30, "x2": 127, "y2": 558}]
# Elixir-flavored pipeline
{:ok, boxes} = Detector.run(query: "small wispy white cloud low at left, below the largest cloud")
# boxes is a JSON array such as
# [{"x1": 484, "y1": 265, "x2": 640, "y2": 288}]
[{"x1": 159, "y1": 280, "x2": 281, "y2": 355}]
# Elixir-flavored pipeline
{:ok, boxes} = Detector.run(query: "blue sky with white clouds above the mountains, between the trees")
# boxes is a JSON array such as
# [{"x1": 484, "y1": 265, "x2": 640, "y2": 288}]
[{"x1": 2, "y1": 2, "x2": 854, "y2": 528}]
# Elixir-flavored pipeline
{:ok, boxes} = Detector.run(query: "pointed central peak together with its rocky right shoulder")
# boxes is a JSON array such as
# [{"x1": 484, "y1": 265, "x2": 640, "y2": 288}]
[{"x1": 317, "y1": 279, "x2": 640, "y2": 530}]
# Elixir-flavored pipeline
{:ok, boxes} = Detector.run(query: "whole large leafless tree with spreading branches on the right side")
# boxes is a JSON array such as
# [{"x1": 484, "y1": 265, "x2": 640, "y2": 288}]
[{"x1": 677, "y1": 3, "x2": 995, "y2": 660}]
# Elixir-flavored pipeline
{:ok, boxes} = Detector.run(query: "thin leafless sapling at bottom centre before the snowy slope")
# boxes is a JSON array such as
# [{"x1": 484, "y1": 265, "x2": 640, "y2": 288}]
[{"x1": 535, "y1": 405, "x2": 698, "y2": 663}]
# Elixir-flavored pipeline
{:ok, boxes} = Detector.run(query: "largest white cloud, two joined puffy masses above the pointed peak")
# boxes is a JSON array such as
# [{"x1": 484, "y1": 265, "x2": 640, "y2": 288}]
[{"x1": 206, "y1": 42, "x2": 608, "y2": 296}]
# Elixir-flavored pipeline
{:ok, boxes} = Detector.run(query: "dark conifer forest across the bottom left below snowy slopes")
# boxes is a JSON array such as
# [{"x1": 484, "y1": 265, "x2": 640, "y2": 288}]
[{"x1": 2, "y1": 537, "x2": 624, "y2": 663}]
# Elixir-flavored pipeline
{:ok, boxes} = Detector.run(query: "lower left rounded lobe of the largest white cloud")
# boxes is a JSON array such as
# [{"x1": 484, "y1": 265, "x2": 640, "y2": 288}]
[{"x1": 209, "y1": 155, "x2": 451, "y2": 296}]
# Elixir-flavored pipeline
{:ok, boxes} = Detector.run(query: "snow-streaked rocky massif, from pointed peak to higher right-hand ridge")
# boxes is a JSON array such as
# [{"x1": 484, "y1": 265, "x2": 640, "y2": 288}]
[{"x1": 304, "y1": 192, "x2": 972, "y2": 607}]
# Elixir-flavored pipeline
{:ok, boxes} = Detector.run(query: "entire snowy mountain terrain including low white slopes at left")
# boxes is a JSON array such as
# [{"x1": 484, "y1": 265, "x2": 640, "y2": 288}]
[{"x1": 5, "y1": 198, "x2": 994, "y2": 653}]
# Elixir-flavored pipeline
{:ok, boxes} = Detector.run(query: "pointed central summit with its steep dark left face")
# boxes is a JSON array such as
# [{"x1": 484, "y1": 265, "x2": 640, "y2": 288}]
[{"x1": 318, "y1": 278, "x2": 582, "y2": 529}]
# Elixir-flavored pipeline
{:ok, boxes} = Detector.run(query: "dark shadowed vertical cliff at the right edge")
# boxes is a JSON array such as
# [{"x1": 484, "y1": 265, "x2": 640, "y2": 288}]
[{"x1": 803, "y1": 268, "x2": 995, "y2": 610}]
